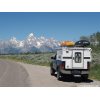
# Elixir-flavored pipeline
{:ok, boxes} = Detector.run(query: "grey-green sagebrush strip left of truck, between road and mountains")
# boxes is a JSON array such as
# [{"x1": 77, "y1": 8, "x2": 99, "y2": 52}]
[{"x1": 0, "y1": 53, "x2": 54, "y2": 66}]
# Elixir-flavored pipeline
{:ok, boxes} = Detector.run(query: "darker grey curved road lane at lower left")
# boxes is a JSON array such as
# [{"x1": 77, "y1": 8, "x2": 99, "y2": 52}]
[{"x1": 0, "y1": 60, "x2": 30, "y2": 87}]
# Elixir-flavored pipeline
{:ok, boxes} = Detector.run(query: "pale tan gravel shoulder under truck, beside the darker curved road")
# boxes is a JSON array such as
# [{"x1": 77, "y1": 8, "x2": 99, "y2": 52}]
[{"x1": 18, "y1": 62, "x2": 100, "y2": 87}]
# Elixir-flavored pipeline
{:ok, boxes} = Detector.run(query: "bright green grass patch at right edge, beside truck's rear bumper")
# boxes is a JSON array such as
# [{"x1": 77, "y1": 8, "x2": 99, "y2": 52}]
[{"x1": 89, "y1": 64, "x2": 100, "y2": 80}]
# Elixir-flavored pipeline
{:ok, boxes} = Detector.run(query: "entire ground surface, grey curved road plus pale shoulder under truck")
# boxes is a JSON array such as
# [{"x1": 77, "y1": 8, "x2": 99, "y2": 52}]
[{"x1": 0, "y1": 60, "x2": 100, "y2": 87}]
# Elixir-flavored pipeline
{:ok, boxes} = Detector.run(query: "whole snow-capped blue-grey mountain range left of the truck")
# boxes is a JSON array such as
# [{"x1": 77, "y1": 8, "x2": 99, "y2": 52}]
[{"x1": 0, "y1": 33, "x2": 60, "y2": 54}]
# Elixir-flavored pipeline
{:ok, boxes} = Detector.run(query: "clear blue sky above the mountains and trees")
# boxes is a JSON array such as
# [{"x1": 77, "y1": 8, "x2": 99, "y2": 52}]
[{"x1": 0, "y1": 12, "x2": 100, "y2": 41}]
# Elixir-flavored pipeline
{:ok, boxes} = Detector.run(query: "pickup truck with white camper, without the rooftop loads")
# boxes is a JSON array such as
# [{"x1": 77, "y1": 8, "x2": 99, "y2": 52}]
[{"x1": 50, "y1": 47, "x2": 92, "y2": 80}]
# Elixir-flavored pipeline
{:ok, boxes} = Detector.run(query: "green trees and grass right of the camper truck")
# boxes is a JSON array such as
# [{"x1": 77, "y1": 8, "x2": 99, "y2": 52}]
[{"x1": 80, "y1": 32, "x2": 100, "y2": 80}]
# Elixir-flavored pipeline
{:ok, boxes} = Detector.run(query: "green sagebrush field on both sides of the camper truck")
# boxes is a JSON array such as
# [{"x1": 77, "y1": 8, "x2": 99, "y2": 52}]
[{"x1": 0, "y1": 53, "x2": 100, "y2": 80}]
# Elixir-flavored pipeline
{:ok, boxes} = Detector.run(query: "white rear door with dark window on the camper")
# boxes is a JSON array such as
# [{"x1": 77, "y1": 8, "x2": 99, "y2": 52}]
[{"x1": 72, "y1": 50, "x2": 84, "y2": 69}]
